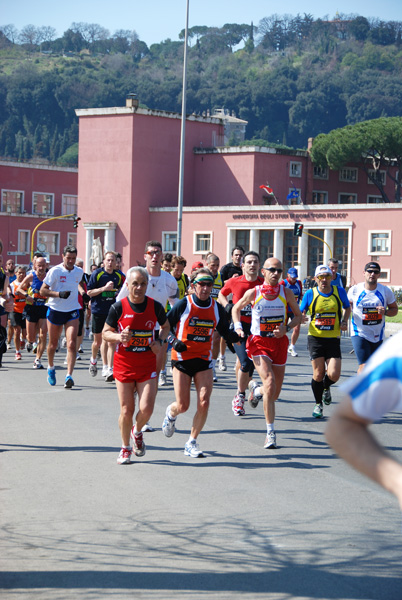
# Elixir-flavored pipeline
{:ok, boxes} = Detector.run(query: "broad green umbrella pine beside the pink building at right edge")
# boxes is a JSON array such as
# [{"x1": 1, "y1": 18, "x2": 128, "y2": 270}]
[{"x1": 310, "y1": 117, "x2": 402, "y2": 202}]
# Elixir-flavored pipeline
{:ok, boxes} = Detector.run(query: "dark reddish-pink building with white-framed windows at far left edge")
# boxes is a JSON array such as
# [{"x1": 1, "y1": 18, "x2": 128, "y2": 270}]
[{"x1": 0, "y1": 161, "x2": 78, "y2": 266}]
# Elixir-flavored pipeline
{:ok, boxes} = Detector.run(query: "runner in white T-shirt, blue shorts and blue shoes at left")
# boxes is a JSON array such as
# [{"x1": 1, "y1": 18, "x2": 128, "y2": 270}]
[{"x1": 40, "y1": 246, "x2": 85, "y2": 389}]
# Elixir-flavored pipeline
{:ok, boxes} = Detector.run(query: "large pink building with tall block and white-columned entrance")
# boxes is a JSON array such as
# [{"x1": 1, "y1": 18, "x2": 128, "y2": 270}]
[{"x1": 77, "y1": 101, "x2": 402, "y2": 287}]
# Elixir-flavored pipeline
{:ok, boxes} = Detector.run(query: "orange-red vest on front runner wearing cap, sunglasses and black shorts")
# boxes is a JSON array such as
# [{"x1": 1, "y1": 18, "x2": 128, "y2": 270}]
[{"x1": 172, "y1": 296, "x2": 219, "y2": 360}]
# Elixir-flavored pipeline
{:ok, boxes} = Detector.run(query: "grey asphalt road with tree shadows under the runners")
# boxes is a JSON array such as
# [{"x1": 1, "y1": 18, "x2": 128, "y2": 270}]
[{"x1": 0, "y1": 331, "x2": 402, "y2": 600}]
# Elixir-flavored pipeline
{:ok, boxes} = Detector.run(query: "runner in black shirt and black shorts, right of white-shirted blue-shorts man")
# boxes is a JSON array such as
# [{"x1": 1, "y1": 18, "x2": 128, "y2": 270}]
[{"x1": 87, "y1": 252, "x2": 125, "y2": 382}]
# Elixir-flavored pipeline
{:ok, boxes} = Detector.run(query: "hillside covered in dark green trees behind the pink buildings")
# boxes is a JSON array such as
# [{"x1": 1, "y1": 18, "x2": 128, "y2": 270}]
[{"x1": 0, "y1": 14, "x2": 402, "y2": 164}]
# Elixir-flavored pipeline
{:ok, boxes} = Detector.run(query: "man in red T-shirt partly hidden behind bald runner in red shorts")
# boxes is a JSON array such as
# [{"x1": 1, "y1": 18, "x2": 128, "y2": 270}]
[{"x1": 218, "y1": 250, "x2": 264, "y2": 417}]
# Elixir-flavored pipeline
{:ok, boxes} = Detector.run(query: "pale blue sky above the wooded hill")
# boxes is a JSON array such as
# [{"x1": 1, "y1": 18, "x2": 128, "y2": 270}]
[{"x1": 0, "y1": 0, "x2": 402, "y2": 46}]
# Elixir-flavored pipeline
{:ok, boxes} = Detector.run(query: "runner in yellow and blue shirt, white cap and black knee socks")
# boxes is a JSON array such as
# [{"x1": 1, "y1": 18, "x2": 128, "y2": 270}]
[{"x1": 300, "y1": 265, "x2": 350, "y2": 419}]
